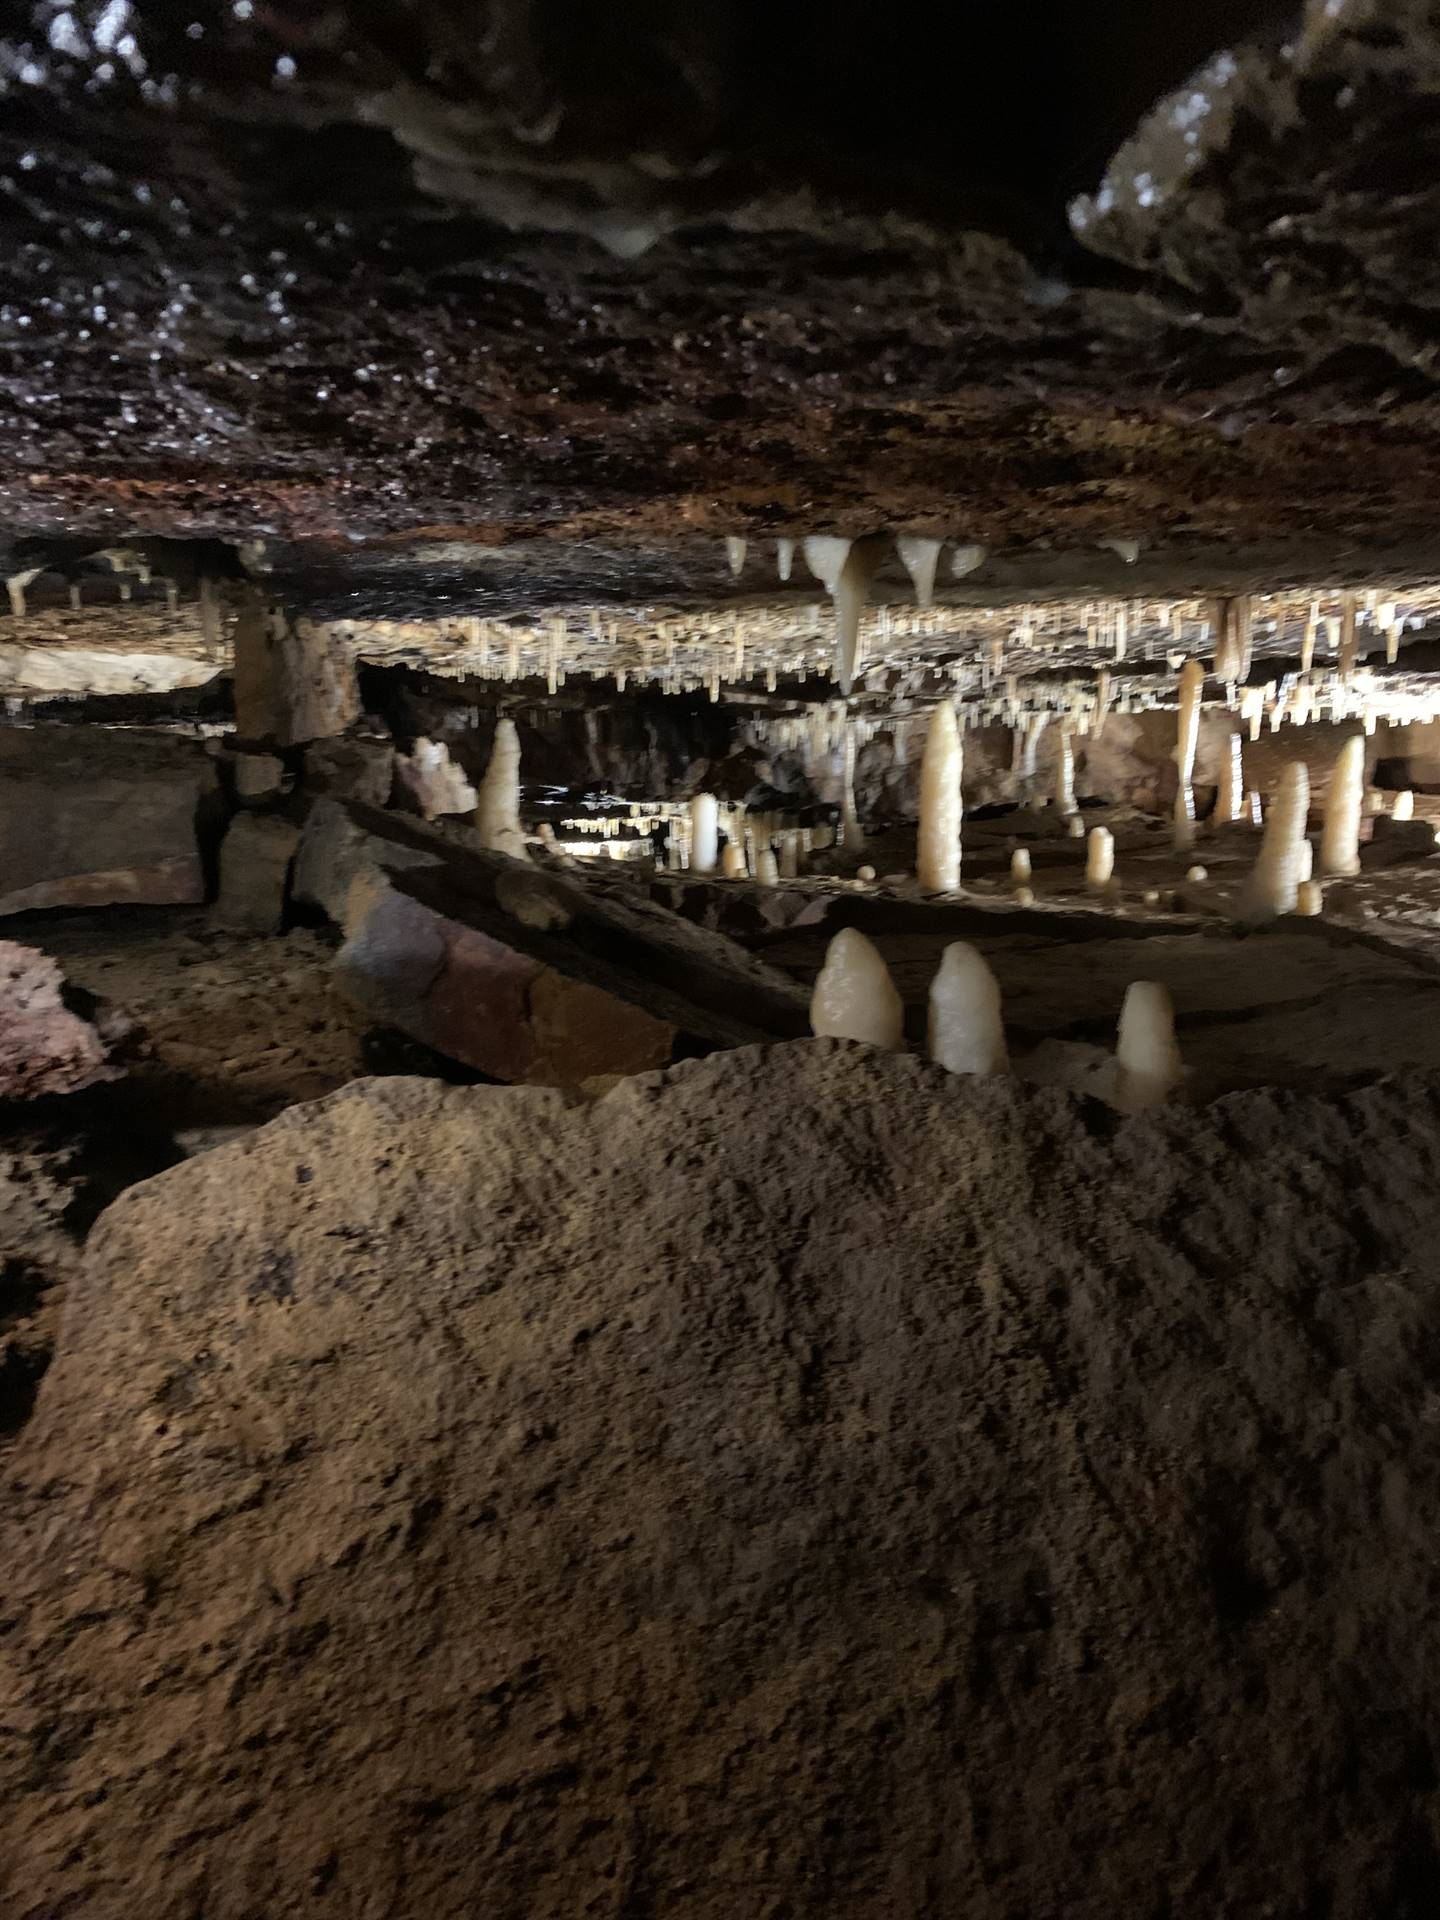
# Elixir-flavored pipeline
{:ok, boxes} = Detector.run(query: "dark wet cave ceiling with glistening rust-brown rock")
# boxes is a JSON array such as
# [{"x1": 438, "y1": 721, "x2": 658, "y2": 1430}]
[{"x1": 0, "y1": 0, "x2": 1440, "y2": 618}]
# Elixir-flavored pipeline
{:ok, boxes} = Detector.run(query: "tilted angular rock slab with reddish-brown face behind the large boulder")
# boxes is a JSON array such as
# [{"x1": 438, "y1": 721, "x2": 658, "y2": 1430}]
[{"x1": 314, "y1": 799, "x2": 808, "y2": 1085}]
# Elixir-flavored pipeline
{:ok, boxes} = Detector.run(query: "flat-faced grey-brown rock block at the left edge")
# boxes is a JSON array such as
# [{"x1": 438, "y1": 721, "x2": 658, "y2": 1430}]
[{"x1": 0, "y1": 728, "x2": 215, "y2": 914}]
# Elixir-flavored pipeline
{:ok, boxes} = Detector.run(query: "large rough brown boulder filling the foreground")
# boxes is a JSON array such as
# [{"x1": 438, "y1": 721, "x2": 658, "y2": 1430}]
[{"x1": 0, "y1": 1041, "x2": 1440, "y2": 1920}]
